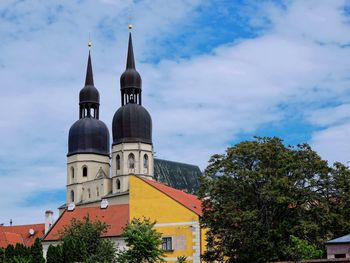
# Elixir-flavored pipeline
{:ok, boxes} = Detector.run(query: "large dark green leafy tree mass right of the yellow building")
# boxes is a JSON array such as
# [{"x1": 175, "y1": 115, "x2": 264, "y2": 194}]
[{"x1": 199, "y1": 137, "x2": 350, "y2": 262}]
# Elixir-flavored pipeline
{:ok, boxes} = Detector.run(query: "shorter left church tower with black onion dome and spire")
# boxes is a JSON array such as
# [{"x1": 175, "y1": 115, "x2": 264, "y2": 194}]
[{"x1": 66, "y1": 51, "x2": 111, "y2": 204}]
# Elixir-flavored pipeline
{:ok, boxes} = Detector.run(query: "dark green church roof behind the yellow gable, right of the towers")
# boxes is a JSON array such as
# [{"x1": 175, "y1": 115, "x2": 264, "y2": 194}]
[{"x1": 154, "y1": 159, "x2": 202, "y2": 194}]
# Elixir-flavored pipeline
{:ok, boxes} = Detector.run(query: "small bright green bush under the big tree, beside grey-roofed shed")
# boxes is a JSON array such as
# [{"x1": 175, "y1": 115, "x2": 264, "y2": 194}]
[{"x1": 290, "y1": 235, "x2": 323, "y2": 260}]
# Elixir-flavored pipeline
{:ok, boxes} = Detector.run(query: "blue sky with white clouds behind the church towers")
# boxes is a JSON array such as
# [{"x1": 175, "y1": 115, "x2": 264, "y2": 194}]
[{"x1": 0, "y1": 0, "x2": 350, "y2": 225}]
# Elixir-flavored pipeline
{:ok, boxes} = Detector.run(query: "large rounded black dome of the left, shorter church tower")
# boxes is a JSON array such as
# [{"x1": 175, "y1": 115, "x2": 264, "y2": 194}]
[{"x1": 67, "y1": 117, "x2": 109, "y2": 156}]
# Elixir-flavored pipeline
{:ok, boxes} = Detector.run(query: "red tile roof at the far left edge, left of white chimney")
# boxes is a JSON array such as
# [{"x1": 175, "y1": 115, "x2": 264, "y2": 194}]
[{"x1": 0, "y1": 224, "x2": 45, "y2": 247}]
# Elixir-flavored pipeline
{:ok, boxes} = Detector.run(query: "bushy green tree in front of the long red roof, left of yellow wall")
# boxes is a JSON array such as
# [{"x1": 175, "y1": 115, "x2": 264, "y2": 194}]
[{"x1": 61, "y1": 217, "x2": 116, "y2": 263}]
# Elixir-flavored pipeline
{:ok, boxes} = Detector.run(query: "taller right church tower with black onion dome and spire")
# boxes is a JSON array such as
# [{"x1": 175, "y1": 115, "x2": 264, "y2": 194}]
[{"x1": 112, "y1": 33, "x2": 154, "y2": 193}]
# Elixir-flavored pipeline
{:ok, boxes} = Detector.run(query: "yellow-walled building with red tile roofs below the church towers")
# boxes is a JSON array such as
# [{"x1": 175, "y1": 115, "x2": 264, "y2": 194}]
[{"x1": 43, "y1": 175, "x2": 205, "y2": 262}]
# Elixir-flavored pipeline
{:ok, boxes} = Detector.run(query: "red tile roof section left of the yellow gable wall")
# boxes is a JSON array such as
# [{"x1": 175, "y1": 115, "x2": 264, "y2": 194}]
[{"x1": 44, "y1": 205, "x2": 129, "y2": 241}]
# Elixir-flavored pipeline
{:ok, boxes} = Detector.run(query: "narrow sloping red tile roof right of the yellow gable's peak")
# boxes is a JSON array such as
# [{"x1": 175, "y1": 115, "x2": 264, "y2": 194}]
[{"x1": 138, "y1": 177, "x2": 202, "y2": 216}]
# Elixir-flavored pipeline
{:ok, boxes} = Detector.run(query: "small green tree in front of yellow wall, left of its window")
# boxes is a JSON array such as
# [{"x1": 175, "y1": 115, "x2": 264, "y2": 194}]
[{"x1": 118, "y1": 218, "x2": 164, "y2": 263}]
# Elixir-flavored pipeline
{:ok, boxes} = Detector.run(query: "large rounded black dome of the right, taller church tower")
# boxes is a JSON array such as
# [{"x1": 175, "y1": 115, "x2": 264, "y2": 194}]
[{"x1": 112, "y1": 103, "x2": 152, "y2": 145}]
